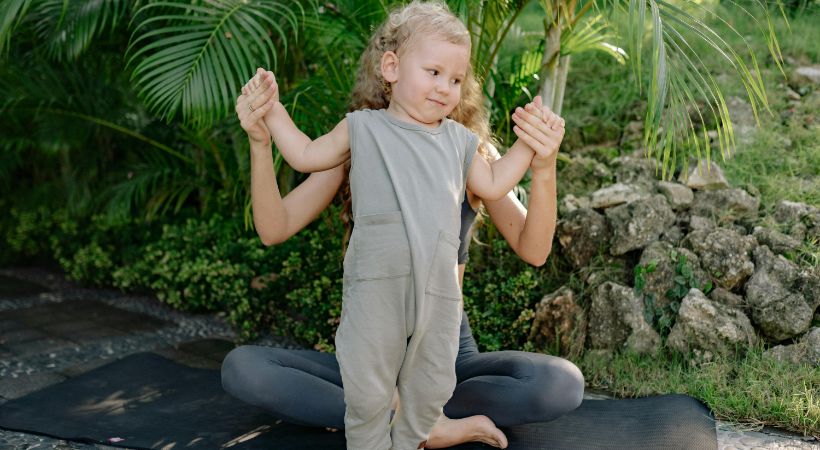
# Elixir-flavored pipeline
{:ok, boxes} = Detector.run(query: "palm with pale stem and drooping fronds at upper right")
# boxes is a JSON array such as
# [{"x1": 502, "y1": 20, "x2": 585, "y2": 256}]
[{"x1": 528, "y1": 0, "x2": 785, "y2": 178}]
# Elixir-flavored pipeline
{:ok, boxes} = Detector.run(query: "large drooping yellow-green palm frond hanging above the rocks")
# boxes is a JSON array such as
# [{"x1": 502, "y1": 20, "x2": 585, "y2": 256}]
[{"x1": 613, "y1": 0, "x2": 782, "y2": 177}]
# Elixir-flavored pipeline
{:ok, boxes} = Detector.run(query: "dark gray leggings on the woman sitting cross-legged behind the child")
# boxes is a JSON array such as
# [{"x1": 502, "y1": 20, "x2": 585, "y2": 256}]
[{"x1": 222, "y1": 313, "x2": 584, "y2": 429}]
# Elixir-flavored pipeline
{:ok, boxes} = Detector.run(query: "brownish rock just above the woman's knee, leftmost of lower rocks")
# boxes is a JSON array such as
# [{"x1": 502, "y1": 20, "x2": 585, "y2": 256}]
[{"x1": 529, "y1": 286, "x2": 586, "y2": 356}]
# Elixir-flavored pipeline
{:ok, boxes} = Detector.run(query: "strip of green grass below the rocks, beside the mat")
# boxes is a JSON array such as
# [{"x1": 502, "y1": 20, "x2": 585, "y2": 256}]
[{"x1": 573, "y1": 347, "x2": 820, "y2": 436}]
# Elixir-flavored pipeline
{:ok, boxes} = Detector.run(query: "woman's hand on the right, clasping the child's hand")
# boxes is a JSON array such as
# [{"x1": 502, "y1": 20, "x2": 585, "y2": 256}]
[{"x1": 512, "y1": 95, "x2": 565, "y2": 176}]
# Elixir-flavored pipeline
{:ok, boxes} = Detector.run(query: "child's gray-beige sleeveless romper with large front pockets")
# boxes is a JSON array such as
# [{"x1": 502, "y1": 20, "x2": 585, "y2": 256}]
[{"x1": 336, "y1": 110, "x2": 478, "y2": 450}]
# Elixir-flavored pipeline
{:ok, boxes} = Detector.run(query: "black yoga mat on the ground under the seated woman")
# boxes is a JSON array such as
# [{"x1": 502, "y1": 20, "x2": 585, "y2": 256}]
[{"x1": 0, "y1": 353, "x2": 717, "y2": 450}]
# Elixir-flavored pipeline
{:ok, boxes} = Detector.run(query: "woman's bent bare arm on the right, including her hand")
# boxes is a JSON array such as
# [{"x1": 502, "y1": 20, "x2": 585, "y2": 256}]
[{"x1": 484, "y1": 97, "x2": 564, "y2": 266}]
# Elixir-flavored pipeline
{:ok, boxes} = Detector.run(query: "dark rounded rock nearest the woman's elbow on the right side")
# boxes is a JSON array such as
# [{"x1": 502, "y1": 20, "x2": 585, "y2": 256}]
[{"x1": 557, "y1": 208, "x2": 610, "y2": 269}]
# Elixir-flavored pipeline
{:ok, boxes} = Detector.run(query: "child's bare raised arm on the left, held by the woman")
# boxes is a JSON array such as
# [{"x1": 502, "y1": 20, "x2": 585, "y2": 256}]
[{"x1": 262, "y1": 72, "x2": 350, "y2": 172}]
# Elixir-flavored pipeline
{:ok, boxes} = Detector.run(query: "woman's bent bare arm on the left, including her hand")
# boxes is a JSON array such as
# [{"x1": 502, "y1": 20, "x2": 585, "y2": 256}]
[{"x1": 236, "y1": 71, "x2": 344, "y2": 245}]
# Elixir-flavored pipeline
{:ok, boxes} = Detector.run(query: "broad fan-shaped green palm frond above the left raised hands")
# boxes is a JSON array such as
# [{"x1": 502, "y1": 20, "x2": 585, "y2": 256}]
[{"x1": 127, "y1": 0, "x2": 301, "y2": 128}]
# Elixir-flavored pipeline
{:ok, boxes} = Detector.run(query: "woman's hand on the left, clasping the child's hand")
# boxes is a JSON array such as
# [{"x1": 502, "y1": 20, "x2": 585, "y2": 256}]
[{"x1": 236, "y1": 68, "x2": 279, "y2": 145}]
